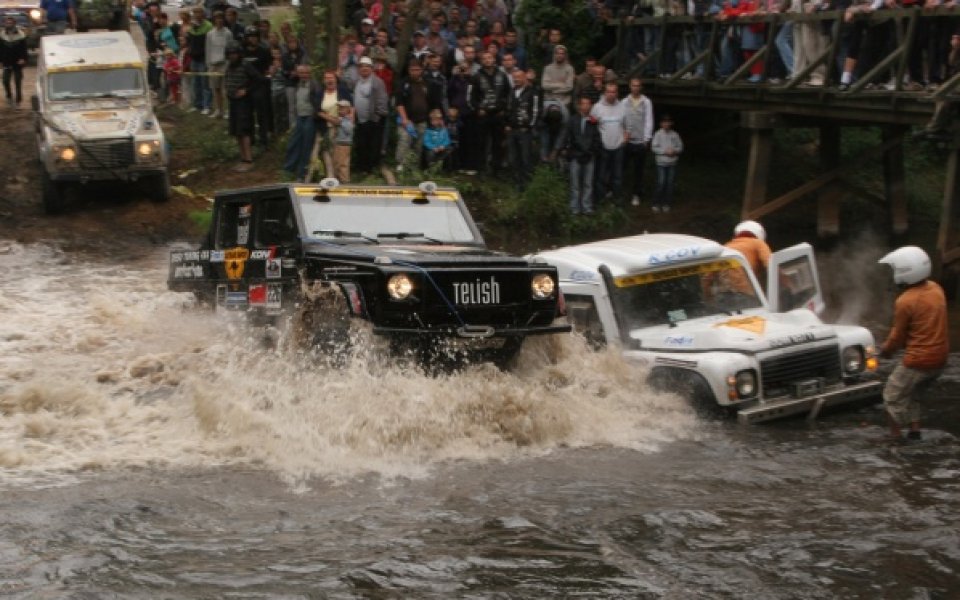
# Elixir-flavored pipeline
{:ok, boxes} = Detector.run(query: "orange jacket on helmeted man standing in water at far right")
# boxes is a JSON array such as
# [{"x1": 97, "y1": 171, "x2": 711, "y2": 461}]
[{"x1": 883, "y1": 280, "x2": 950, "y2": 369}]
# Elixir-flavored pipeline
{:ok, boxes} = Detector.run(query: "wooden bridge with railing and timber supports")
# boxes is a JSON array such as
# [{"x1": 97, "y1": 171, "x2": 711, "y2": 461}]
[{"x1": 601, "y1": 8, "x2": 960, "y2": 269}]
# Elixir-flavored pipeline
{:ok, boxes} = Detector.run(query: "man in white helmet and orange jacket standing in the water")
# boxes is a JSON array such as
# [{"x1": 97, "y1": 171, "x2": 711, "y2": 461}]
[{"x1": 878, "y1": 246, "x2": 950, "y2": 441}]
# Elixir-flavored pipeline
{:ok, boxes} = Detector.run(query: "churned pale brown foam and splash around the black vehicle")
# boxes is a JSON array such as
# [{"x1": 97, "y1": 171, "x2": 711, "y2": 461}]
[{"x1": 0, "y1": 245, "x2": 699, "y2": 481}]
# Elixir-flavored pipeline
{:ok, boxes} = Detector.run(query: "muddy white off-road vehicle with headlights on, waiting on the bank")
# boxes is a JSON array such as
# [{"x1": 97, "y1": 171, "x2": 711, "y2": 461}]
[{"x1": 32, "y1": 31, "x2": 170, "y2": 213}]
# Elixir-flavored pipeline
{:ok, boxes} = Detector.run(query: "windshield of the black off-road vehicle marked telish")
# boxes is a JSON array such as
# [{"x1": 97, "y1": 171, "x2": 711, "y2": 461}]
[{"x1": 300, "y1": 194, "x2": 480, "y2": 244}]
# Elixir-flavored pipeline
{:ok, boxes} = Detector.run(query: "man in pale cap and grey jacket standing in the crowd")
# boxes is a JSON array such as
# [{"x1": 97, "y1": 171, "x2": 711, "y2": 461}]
[{"x1": 353, "y1": 56, "x2": 389, "y2": 172}]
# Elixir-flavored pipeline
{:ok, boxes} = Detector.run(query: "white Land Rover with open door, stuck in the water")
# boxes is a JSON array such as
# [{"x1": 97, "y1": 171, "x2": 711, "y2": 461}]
[{"x1": 535, "y1": 234, "x2": 882, "y2": 423}]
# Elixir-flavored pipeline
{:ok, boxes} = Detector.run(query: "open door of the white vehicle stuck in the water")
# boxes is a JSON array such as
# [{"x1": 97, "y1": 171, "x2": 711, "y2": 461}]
[{"x1": 767, "y1": 242, "x2": 826, "y2": 315}]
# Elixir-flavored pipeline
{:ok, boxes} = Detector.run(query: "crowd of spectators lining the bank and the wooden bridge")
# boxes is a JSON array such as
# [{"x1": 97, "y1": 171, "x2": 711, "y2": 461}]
[{"x1": 133, "y1": 0, "x2": 960, "y2": 214}]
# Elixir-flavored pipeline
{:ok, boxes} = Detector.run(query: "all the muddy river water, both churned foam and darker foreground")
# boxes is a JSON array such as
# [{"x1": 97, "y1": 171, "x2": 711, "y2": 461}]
[{"x1": 0, "y1": 242, "x2": 960, "y2": 599}]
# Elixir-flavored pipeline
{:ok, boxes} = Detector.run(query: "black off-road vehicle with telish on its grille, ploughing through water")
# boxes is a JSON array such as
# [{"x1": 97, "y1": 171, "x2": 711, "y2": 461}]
[{"x1": 169, "y1": 179, "x2": 570, "y2": 363}]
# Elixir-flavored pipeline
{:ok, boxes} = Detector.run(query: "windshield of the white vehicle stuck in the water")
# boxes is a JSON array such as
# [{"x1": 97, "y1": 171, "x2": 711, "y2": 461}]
[{"x1": 613, "y1": 258, "x2": 762, "y2": 329}]
